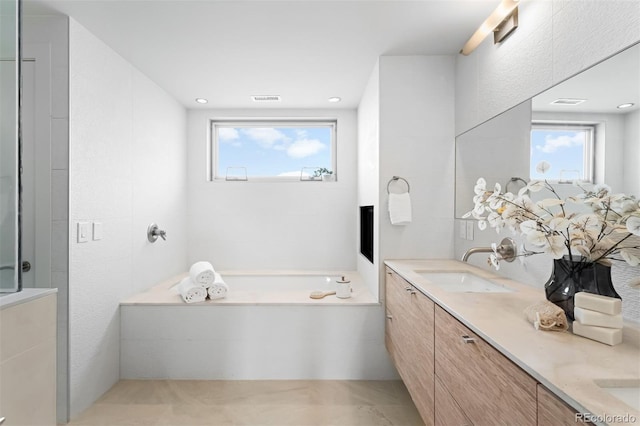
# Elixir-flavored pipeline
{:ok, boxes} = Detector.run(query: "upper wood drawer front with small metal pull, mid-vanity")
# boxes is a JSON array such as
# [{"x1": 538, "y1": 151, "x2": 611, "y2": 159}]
[{"x1": 435, "y1": 307, "x2": 537, "y2": 426}]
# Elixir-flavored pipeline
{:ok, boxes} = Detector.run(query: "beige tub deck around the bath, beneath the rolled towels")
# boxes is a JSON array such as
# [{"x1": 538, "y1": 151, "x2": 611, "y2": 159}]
[{"x1": 120, "y1": 271, "x2": 379, "y2": 306}]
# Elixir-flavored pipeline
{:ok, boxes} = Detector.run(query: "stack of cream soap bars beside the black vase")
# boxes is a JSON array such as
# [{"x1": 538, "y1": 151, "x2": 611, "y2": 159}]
[{"x1": 573, "y1": 292, "x2": 623, "y2": 346}]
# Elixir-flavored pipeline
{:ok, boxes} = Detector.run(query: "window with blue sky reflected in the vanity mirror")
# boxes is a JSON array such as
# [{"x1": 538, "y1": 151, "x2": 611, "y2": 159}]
[{"x1": 529, "y1": 123, "x2": 595, "y2": 183}]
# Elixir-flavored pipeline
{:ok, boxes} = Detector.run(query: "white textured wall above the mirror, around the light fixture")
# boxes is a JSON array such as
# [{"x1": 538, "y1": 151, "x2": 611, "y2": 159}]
[{"x1": 455, "y1": 0, "x2": 640, "y2": 134}]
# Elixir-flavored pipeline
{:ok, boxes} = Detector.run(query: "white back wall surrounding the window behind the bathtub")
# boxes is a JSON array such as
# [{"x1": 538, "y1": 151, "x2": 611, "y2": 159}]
[{"x1": 187, "y1": 109, "x2": 358, "y2": 270}]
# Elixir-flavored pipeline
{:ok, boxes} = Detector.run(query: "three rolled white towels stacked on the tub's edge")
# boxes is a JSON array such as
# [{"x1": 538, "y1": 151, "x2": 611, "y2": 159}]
[{"x1": 177, "y1": 261, "x2": 229, "y2": 303}]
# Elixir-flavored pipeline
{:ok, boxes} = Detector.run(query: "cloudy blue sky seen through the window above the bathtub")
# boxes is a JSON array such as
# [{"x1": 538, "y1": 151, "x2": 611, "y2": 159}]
[{"x1": 215, "y1": 126, "x2": 332, "y2": 177}]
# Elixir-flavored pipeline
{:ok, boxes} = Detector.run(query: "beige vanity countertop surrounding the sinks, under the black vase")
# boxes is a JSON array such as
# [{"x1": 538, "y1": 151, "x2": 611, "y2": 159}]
[{"x1": 385, "y1": 260, "x2": 640, "y2": 421}]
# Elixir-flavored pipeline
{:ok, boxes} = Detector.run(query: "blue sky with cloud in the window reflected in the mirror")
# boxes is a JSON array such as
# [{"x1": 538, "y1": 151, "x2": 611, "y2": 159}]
[{"x1": 529, "y1": 129, "x2": 586, "y2": 180}]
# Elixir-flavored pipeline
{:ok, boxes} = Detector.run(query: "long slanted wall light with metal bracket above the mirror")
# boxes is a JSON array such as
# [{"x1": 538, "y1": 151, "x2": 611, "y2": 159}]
[{"x1": 460, "y1": 0, "x2": 519, "y2": 56}]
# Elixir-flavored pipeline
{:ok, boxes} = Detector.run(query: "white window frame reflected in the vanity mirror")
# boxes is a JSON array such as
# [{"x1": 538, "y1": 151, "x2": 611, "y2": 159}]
[{"x1": 529, "y1": 120, "x2": 598, "y2": 184}]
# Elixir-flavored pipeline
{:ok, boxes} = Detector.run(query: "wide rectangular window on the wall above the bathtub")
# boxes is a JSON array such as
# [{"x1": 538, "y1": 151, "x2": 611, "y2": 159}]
[{"x1": 211, "y1": 119, "x2": 336, "y2": 181}]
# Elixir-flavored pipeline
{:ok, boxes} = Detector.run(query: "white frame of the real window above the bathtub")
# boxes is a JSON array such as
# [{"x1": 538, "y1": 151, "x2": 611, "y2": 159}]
[{"x1": 207, "y1": 117, "x2": 338, "y2": 182}]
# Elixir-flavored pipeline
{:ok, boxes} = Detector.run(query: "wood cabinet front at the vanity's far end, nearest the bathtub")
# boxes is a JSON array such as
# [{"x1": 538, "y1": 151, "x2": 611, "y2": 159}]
[{"x1": 385, "y1": 268, "x2": 435, "y2": 425}]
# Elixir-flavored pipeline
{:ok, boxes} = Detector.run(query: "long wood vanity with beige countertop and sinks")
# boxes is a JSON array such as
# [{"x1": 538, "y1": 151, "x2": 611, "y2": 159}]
[{"x1": 385, "y1": 260, "x2": 640, "y2": 426}]
